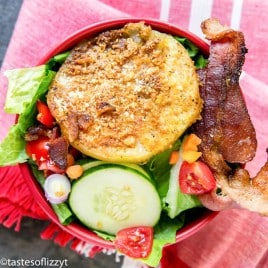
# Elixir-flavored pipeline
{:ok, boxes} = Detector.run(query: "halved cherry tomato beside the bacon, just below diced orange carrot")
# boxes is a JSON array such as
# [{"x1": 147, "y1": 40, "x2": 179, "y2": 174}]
[{"x1": 179, "y1": 161, "x2": 216, "y2": 195}]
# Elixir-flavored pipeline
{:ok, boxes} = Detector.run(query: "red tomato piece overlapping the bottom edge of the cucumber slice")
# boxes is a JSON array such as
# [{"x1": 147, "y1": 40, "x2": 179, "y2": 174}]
[{"x1": 114, "y1": 226, "x2": 153, "y2": 258}]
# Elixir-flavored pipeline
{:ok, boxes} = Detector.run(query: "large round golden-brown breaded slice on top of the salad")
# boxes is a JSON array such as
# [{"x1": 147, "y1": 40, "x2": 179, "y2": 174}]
[{"x1": 47, "y1": 22, "x2": 202, "y2": 163}]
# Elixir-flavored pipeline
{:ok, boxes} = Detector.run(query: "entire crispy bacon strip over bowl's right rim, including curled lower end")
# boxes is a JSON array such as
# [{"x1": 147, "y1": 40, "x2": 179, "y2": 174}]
[{"x1": 193, "y1": 19, "x2": 268, "y2": 215}]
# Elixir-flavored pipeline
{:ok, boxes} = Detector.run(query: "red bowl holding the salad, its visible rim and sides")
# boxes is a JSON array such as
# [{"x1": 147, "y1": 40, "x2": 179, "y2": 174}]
[{"x1": 20, "y1": 18, "x2": 217, "y2": 248}]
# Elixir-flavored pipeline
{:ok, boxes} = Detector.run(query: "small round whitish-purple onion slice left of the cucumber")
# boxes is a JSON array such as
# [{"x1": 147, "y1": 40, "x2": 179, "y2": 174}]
[{"x1": 44, "y1": 174, "x2": 71, "y2": 204}]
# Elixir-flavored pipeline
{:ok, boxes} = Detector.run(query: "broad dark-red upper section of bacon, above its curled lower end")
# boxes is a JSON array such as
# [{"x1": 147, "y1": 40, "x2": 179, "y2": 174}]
[{"x1": 196, "y1": 19, "x2": 257, "y2": 163}]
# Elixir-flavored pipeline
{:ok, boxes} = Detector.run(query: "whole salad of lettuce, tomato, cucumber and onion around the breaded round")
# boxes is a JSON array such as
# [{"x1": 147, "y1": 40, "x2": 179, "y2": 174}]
[{"x1": 0, "y1": 24, "x2": 216, "y2": 266}]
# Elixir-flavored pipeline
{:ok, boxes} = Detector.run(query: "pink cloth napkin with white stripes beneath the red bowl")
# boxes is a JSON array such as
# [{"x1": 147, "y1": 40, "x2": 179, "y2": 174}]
[{"x1": 0, "y1": 0, "x2": 268, "y2": 268}]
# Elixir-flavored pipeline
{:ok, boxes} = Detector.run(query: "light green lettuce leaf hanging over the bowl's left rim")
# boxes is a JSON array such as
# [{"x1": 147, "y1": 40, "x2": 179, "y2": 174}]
[{"x1": 0, "y1": 65, "x2": 56, "y2": 166}]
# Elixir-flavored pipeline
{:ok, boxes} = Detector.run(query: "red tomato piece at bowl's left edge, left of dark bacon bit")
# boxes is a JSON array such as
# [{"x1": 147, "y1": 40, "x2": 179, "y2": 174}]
[{"x1": 25, "y1": 136, "x2": 49, "y2": 161}]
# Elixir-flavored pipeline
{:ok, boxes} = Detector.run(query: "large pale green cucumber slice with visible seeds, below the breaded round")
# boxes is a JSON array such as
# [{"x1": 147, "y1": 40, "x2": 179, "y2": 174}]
[{"x1": 69, "y1": 164, "x2": 161, "y2": 234}]
